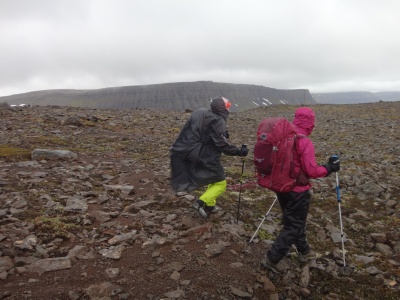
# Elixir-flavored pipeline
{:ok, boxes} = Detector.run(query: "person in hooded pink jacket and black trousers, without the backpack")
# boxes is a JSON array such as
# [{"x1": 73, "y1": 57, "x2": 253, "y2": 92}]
[{"x1": 262, "y1": 107, "x2": 340, "y2": 273}]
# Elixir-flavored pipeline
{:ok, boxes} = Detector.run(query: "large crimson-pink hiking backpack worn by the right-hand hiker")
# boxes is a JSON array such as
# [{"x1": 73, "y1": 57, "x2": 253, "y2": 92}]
[{"x1": 254, "y1": 118, "x2": 304, "y2": 193}]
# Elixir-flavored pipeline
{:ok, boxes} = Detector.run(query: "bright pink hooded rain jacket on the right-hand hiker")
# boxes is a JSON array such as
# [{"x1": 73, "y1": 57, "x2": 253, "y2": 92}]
[{"x1": 292, "y1": 107, "x2": 328, "y2": 192}]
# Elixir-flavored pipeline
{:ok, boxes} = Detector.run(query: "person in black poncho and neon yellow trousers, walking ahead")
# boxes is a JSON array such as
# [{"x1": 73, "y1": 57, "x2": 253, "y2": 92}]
[{"x1": 171, "y1": 97, "x2": 248, "y2": 218}]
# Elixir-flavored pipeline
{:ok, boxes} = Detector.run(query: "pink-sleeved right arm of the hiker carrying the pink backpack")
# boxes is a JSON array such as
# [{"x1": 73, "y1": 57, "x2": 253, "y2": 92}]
[{"x1": 299, "y1": 138, "x2": 328, "y2": 178}]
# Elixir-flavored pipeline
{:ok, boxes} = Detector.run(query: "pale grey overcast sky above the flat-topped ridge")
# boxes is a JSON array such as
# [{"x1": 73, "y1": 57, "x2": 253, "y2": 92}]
[{"x1": 0, "y1": 0, "x2": 400, "y2": 96}]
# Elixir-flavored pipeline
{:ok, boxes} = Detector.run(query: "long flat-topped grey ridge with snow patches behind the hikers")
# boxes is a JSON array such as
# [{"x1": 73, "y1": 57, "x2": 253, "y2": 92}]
[{"x1": 0, "y1": 81, "x2": 316, "y2": 112}]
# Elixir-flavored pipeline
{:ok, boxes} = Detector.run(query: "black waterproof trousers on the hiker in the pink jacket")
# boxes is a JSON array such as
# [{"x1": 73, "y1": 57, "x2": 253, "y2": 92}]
[{"x1": 267, "y1": 191, "x2": 311, "y2": 263}]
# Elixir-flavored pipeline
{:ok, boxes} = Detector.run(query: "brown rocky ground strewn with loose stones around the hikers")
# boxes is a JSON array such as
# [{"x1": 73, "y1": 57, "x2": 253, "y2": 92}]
[{"x1": 0, "y1": 102, "x2": 400, "y2": 300}]
